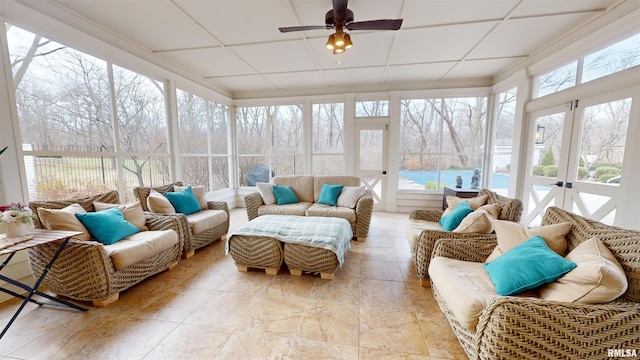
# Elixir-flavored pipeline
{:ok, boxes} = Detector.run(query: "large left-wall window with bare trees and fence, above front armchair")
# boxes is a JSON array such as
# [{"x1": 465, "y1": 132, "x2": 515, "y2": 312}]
[{"x1": 6, "y1": 24, "x2": 168, "y2": 200}]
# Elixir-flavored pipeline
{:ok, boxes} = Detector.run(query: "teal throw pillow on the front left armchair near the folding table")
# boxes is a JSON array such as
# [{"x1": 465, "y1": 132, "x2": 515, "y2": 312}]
[{"x1": 75, "y1": 207, "x2": 140, "y2": 245}]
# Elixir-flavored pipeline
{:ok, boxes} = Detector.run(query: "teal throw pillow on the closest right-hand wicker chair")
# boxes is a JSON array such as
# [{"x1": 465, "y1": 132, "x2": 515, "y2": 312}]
[{"x1": 484, "y1": 235, "x2": 577, "y2": 295}]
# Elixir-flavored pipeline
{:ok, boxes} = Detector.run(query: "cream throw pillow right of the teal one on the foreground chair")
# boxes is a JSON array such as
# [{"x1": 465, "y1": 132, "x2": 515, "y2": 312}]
[{"x1": 540, "y1": 237, "x2": 629, "y2": 304}]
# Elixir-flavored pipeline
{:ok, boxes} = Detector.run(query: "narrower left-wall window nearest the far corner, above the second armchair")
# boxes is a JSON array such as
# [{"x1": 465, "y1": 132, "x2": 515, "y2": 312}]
[{"x1": 176, "y1": 89, "x2": 229, "y2": 191}]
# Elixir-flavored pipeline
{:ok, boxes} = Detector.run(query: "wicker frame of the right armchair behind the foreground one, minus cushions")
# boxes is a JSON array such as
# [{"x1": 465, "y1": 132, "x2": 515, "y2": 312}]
[{"x1": 409, "y1": 189, "x2": 523, "y2": 286}]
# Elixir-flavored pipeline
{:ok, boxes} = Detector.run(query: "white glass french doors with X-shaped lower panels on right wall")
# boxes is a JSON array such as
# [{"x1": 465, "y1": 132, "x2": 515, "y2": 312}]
[{"x1": 522, "y1": 87, "x2": 638, "y2": 226}]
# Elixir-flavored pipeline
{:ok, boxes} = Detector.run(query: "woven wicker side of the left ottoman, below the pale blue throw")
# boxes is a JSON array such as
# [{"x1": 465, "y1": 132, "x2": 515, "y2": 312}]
[{"x1": 228, "y1": 235, "x2": 284, "y2": 269}]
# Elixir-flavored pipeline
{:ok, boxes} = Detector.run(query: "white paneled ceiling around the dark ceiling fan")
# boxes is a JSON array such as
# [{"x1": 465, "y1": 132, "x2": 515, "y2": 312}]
[{"x1": 18, "y1": 0, "x2": 624, "y2": 97}]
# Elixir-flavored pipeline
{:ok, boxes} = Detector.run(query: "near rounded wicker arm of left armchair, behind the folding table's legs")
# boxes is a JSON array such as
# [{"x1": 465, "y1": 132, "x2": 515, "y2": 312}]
[{"x1": 28, "y1": 239, "x2": 115, "y2": 299}]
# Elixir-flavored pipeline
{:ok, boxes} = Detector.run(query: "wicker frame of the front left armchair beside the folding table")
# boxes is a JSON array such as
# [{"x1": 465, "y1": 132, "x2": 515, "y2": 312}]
[{"x1": 28, "y1": 191, "x2": 184, "y2": 307}]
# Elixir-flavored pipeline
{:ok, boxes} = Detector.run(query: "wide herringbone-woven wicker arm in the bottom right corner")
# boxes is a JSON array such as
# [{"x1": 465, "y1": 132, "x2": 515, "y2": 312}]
[{"x1": 476, "y1": 296, "x2": 640, "y2": 359}]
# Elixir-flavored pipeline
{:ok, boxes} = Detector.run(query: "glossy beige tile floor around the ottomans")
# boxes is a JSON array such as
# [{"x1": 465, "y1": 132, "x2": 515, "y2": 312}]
[{"x1": 0, "y1": 209, "x2": 466, "y2": 360}]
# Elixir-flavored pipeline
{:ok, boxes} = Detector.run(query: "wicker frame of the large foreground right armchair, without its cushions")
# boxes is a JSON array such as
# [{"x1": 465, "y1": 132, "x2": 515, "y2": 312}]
[{"x1": 432, "y1": 207, "x2": 640, "y2": 360}]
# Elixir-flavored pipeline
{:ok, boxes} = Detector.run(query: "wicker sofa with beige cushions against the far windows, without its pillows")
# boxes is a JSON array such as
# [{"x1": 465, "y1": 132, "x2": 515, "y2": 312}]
[{"x1": 244, "y1": 175, "x2": 373, "y2": 241}]
